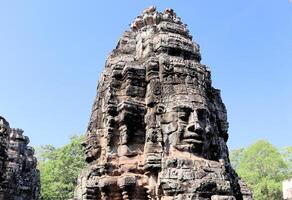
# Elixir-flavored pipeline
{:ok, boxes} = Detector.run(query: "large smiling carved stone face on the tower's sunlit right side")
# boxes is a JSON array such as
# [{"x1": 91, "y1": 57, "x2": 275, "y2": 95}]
[{"x1": 162, "y1": 101, "x2": 214, "y2": 156}]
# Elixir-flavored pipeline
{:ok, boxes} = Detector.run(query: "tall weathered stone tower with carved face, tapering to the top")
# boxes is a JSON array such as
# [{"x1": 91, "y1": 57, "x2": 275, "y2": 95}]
[{"x1": 75, "y1": 7, "x2": 252, "y2": 200}]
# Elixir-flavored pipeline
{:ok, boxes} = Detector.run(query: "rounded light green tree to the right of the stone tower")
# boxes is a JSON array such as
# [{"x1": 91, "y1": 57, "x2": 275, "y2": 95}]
[{"x1": 237, "y1": 140, "x2": 291, "y2": 200}]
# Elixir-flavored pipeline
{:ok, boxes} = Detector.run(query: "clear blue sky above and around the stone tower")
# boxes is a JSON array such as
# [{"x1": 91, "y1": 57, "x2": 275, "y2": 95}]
[{"x1": 0, "y1": 0, "x2": 292, "y2": 149}]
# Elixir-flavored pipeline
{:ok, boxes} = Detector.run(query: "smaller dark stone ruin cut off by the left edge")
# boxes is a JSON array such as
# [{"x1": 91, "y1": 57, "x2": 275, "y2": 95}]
[{"x1": 0, "y1": 116, "x2": 40, "y2": 200}]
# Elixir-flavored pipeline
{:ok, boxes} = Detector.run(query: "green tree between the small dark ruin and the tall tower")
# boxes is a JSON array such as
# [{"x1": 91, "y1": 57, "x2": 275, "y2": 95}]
[{"x1": 37, "y1": 136, "x2": 86, "y2": 200}]
